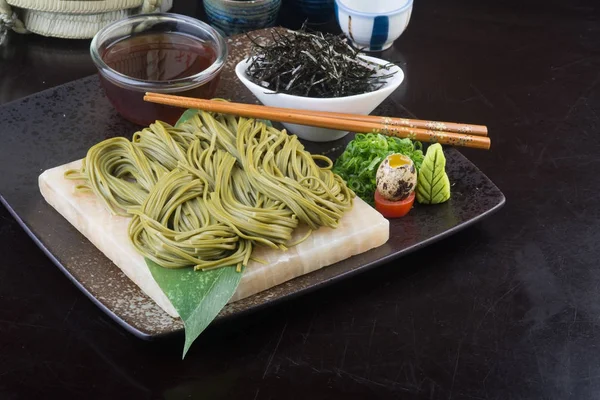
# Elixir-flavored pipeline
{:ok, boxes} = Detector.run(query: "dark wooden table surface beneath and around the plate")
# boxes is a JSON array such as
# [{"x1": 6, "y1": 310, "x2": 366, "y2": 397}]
[{"x1": 0, "y1": 0, "x2": 600, "y2": 400}]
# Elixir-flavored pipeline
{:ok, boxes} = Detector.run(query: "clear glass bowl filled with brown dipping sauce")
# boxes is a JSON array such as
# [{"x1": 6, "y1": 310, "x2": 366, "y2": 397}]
[{"x1": 90, "y1": 13, "x2": 227, "y2": 126}]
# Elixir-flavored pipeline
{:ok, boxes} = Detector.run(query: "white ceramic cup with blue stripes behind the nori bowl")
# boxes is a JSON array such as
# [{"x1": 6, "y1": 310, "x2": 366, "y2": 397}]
[{"x1": 335, "y1": 0, "x2": 413, "y2": 51}]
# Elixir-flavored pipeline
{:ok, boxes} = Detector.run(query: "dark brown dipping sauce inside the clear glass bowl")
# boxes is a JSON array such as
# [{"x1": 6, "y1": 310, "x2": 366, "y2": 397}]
[{"x1": 100, "y1": 33, "x2": 220, "y2": 126}]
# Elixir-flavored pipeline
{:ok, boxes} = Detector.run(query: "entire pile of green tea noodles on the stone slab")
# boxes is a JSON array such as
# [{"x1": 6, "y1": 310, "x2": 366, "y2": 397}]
[{"x1": 65, "y1": 111, "x2": 354, "y2": 270}]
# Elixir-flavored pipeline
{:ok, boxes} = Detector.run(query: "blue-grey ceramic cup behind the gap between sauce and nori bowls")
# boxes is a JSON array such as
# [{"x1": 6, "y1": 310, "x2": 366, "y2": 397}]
[{"x1": 204, "y1": 0, "x2": 281, "y2": 35}]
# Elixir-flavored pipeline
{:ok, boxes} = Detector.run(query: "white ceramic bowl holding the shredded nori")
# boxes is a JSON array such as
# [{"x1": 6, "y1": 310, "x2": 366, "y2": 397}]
[{"x1": 235, "y1": 56, "x2": 404, "y2": 142}]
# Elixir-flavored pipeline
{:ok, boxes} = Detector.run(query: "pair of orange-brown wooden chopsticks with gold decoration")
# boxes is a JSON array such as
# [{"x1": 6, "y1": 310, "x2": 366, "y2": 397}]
[{"x1": 144, "y1": 92, "x2": 491, "y2": 150}]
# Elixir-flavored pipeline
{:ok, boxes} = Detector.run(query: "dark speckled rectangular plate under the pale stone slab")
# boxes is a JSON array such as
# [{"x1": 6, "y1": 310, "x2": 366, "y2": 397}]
[{"x1": 0, "y1": 31, "x2": 505, "y2": 339}]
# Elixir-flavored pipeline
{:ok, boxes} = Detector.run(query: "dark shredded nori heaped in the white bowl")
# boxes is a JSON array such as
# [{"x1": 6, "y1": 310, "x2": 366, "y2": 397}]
[{"x1": 246, "y1": 26, "x2": 395, "y2": 98}]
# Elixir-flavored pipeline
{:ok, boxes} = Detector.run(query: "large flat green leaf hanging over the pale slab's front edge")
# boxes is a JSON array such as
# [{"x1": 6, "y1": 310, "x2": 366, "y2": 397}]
[{"x1": 145, "y1": 258, "x2": 242, "y2": 359}]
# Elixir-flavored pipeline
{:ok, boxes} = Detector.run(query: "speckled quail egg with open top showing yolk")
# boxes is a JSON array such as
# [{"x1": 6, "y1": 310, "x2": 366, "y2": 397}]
[{"x1": 376, "y1": 153, "x2": 417, "y2": 201}]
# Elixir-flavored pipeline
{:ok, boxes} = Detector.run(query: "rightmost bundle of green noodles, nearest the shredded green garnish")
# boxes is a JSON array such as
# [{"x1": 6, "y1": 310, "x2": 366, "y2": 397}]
[{"x1": 181, "y1": 113, "x2": 354, "y2": 230}]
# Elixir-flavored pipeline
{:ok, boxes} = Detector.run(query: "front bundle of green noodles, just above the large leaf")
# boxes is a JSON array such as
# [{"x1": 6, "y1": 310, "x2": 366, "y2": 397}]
[{"x1": 129, "y1": 169, "x2": 252, "y2": 269}]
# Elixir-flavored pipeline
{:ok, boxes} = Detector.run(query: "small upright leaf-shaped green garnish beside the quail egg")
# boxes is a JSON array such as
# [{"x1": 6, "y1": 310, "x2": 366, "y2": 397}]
[{"x1": 417, "y1": 143, "x2": 450, "y2": 204}]
